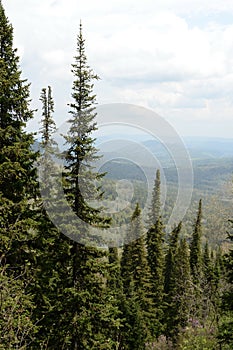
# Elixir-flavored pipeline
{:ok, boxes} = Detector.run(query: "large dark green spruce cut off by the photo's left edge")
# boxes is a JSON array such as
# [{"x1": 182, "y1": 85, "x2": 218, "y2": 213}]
[{"x1": 0, "y1": 1, "x2": 37, "y2": 349}]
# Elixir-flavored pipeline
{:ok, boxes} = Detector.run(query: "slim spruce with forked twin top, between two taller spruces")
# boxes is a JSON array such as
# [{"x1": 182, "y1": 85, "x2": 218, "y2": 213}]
[{"x1": 28, "y1": 87, "x2": 72, "y2": 349}]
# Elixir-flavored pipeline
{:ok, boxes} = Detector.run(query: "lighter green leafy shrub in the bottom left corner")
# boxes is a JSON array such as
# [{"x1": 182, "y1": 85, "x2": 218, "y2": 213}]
[{"x1": 0, "y1": 265, "x2": 39, "y2": 350}]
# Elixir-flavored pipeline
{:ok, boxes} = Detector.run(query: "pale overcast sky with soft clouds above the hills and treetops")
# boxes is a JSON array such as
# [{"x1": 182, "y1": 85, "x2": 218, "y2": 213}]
[{"x1": 2, "y1": 0, "x2": 233, "y2": 138}]
